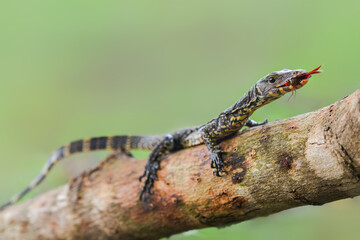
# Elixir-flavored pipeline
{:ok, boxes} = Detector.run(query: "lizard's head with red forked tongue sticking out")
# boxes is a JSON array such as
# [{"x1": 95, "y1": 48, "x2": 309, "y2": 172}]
[{"x1": 255, "y1": 66, "x2": 321, "y2": 99}]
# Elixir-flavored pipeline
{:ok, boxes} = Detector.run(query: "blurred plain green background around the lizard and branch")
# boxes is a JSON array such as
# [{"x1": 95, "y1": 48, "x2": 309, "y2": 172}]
[{"x1": 0, "y1": 0, "x2": 360, "y2": 240}]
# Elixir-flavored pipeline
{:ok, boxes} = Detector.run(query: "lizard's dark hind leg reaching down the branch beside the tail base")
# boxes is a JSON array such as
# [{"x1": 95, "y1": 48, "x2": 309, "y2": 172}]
[{"x1": 139, "y1": 134, "x2": 174, "y2": 201}]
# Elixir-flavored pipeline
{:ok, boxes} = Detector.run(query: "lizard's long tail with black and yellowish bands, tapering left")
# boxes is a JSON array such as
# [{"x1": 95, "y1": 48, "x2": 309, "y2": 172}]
[{"x1": 0, "y1": 136, "x2": 162, "y2": 211}]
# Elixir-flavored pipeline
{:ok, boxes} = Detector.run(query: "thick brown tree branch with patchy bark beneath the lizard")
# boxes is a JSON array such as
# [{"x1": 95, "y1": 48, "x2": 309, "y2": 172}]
[{"x1": 0, "y1": 90, "x2": 360, "y2": 239}]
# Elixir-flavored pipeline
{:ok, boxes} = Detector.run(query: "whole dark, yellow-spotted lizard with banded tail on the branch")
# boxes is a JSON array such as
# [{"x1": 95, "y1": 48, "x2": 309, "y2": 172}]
[{"x1": 0, "y1": 66, "x2": 321, "y2": 210}]
